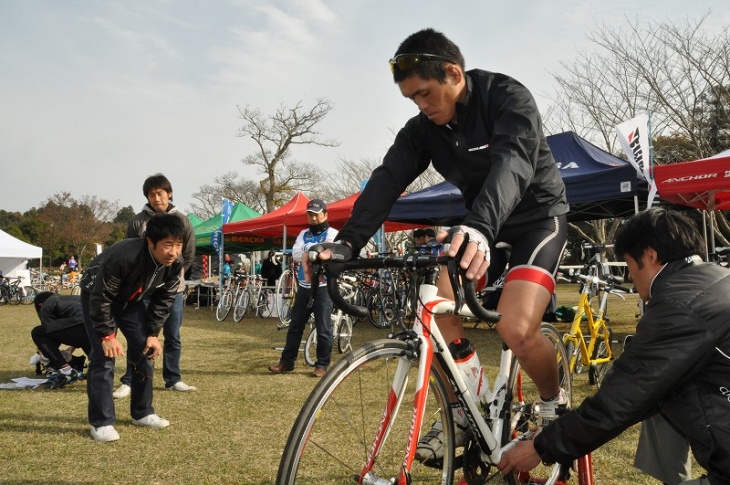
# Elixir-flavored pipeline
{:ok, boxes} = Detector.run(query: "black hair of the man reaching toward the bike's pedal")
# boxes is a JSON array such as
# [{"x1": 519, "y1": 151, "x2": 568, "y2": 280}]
[{"x1": 614, "y1": 207, "x2": 705, "y2": 268}]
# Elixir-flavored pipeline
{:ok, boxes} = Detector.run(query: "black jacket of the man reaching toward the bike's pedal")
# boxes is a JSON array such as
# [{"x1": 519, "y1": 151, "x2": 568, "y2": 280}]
[{"x1": 535, "y1": 258, "x2": 730, "y2": 485}]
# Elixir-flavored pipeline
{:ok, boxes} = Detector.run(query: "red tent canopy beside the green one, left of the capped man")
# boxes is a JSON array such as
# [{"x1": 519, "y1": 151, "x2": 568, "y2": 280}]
[{"x1": 223, "y1": 192, "x2": 309, "y2": 238}]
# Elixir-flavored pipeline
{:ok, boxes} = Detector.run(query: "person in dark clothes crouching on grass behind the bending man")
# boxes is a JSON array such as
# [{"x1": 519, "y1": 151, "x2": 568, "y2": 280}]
[{"x1": 30, "y1": 291, "x2": 91, "y2": 389}]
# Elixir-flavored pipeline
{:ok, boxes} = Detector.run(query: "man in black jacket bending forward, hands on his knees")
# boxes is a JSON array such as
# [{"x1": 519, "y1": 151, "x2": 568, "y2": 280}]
[{"x1": 81, "y1": 214, "x2": 185, "y2": 441}]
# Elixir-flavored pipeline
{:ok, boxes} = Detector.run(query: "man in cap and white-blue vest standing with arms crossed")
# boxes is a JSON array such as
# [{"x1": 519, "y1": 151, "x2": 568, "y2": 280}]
[{"x1": 269, "y1": 199, "x2": 337, "y2": 377}]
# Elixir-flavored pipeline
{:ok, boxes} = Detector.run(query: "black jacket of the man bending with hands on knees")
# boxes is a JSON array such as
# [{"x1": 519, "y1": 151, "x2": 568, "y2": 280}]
[{"x1": 81, "y1": 238, "x2": 182, "y2": 337}]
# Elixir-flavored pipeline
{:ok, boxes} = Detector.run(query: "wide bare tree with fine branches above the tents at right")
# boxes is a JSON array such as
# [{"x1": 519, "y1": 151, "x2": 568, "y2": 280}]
[{"x1": 545, "y1": 12, "x2": 730, "y2": 248}]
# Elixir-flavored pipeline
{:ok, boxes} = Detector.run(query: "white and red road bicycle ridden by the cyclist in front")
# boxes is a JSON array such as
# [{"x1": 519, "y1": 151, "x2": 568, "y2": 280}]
[{"x1": 276, "y1": 244, "x2": 592, "y2": 485}]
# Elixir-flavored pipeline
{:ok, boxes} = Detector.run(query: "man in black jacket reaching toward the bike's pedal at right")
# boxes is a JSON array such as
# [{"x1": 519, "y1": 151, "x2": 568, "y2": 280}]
[{"x1": 499, "y1": 208, "x2": 730, "y2": 485}]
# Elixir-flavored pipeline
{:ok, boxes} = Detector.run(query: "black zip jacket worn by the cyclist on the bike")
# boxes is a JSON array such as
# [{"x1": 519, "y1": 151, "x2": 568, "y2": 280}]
[{"x1": 337, "y1": 69, "x2": 569, "y2": 254}]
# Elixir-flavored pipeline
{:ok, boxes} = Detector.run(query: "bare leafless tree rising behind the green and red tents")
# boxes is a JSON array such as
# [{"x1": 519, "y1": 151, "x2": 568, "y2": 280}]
[{"x1": 238, "y1": 98, "x2": 339, "y2": 212}]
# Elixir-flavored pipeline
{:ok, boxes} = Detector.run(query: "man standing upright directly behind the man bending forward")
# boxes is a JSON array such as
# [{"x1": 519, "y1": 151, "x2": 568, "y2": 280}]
[{"x1": 114, "y1": 173, "x2": 197, "y2": 399}]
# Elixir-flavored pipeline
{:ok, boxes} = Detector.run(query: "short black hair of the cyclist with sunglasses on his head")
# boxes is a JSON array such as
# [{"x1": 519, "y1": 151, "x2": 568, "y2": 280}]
[{"x1": 393, "y1": 28, "x2": 466, "y2": 84}]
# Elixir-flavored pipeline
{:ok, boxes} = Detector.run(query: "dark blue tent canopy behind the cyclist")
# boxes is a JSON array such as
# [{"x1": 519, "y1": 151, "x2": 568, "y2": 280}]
[{"x1": 388, "y1": 131, "x2": 646, "y2": 226}]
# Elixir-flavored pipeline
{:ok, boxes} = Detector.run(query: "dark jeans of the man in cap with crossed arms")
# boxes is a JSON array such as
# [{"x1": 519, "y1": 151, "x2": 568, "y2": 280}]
[{"x1": 281, "y1": 285, "x2": 332, "y2": 369}]
